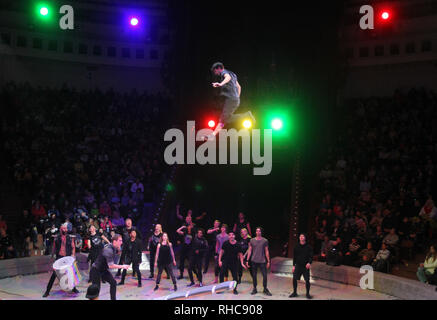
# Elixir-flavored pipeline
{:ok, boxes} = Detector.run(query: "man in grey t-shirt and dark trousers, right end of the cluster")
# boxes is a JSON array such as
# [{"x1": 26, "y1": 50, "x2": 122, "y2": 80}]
[{"x1": 246, "y1": 227, "x2": 272, "y2": 296}]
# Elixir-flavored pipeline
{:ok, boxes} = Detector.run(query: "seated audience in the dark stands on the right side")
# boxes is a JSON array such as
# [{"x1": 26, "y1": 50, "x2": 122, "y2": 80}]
[{"x1": 314, "y1": 89, "x2": 437, "y2": 272}]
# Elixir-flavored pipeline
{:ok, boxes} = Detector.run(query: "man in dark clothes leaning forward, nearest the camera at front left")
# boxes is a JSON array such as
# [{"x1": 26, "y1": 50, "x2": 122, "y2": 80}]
[{"x1": 90, "y1": 234, "x2": 129, "y2": 300}]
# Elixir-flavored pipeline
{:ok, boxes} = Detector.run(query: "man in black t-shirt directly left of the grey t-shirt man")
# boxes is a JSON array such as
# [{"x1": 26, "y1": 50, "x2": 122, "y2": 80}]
[{"x1": 218, "y1": 232, "x2": 246, "y2": 294}]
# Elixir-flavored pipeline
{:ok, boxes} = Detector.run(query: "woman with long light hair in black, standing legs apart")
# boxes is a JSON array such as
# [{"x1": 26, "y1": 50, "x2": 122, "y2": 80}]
[{"x1": 153, "y1": 232, "x2": 178, "y2": 291}]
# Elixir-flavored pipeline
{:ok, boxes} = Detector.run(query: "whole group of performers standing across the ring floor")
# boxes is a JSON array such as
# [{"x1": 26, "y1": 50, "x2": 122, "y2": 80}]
[{"x1": 43, "y1": 208, "x2": 312, "y2": 300}]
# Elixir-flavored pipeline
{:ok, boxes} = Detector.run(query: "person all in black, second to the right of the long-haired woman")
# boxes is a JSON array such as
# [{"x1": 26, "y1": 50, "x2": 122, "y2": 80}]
[{"x1": 188, "y1": 229, "x2": 208, "y2": 287}]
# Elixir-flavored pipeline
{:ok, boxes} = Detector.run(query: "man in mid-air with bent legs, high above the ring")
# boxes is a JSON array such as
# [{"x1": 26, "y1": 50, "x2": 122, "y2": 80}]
[{"x1": 205, "y1": 62, "x2": 255, "y2": 140}]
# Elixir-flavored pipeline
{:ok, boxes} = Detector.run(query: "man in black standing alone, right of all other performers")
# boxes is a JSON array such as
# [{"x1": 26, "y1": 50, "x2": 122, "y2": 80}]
[{"x1": 289, "y1": 233, "x2": 313, "y2": 299}]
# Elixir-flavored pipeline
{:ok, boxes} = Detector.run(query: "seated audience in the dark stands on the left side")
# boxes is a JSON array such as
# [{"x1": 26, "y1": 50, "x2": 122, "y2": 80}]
[{"x1": 0, "y1": 83, "x2": 172, "y2": 258}]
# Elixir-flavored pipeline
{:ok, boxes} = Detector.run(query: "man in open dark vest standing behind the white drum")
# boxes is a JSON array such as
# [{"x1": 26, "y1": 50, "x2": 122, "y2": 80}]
[{"x1": 43, "y1": 223, "x2": 79, "y2": 298}]
